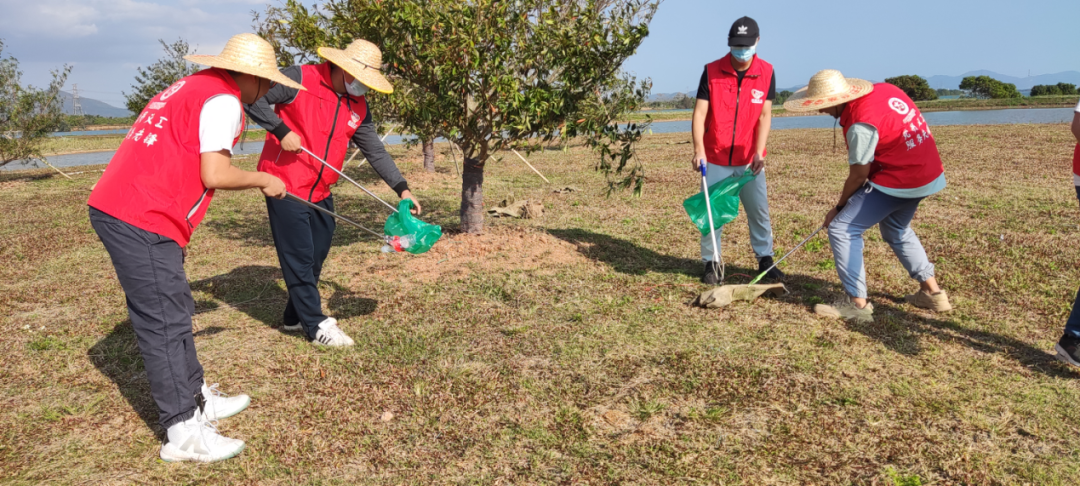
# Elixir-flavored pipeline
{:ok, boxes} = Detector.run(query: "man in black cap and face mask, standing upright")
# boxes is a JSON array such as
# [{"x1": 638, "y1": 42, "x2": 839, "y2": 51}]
[{"x1": 692, "y1": 17, "x2": 784, "y2": 285}]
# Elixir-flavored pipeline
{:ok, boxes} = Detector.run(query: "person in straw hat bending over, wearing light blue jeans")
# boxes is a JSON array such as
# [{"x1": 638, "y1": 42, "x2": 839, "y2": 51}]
[{"x1": 784, "y1": 69, "x2": 953, "y2": 322}]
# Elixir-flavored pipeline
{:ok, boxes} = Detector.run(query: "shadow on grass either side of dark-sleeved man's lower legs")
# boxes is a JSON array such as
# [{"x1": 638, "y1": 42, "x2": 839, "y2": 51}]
[{"x1": 190, "y1": 266, "x2": 378, "y2": 336}]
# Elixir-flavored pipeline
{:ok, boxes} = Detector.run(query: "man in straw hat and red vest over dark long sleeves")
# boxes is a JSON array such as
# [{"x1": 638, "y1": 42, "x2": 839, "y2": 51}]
[{"x1": 246, "y1": 40, "x2": 420, "y2": 346}]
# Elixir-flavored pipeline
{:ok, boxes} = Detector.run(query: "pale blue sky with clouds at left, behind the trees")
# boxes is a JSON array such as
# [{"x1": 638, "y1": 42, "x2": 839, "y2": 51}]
[{"x1": 0, "y1": 0, "x2": 1080, "y2": 107}]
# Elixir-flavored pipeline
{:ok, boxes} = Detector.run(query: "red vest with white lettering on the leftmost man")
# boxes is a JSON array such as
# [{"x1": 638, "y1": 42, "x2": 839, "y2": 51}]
[{"x1": 87, "y1": 68, "x2": 244, "y2": 247}]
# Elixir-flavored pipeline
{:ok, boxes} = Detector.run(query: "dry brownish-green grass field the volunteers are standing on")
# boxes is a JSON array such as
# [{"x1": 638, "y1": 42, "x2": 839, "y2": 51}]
[{"x1": 0, "y1": 125, "x2": 1080, "y2": 486}]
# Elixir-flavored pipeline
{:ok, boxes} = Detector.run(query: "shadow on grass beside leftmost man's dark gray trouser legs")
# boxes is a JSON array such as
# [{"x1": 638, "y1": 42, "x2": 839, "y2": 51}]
[{"x1": 86, "y1": 320, "x2": 165, "y2": 441}]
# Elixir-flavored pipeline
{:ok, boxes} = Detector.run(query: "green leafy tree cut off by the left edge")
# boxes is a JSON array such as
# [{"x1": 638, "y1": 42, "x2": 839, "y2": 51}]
[{"x1": 0, "y1": 40, "x2": 71, "y2": 166}]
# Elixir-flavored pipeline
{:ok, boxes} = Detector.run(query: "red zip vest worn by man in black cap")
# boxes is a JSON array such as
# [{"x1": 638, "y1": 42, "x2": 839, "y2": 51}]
[{"x1": 704, "y1": 53, "x2": 772, "y2": 165}]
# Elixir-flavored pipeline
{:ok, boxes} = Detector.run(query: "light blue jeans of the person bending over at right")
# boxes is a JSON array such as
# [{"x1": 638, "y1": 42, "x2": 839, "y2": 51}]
[{"x1": 828, "y1": 184, "x2": 934, "y2": 299}]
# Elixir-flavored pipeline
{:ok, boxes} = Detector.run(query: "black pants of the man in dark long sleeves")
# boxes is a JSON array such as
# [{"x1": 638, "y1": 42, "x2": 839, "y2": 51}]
[{"x1": 267, "y1": 195, "x2": 337, "y2": 339}]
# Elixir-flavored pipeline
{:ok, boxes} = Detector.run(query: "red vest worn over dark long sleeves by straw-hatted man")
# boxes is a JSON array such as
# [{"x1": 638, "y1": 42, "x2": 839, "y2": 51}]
[{"x1": 258, "y1": 63, "x2": 367, "y2": 202}]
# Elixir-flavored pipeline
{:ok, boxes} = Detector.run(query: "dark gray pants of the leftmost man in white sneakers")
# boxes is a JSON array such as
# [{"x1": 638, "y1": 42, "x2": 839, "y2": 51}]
[{"x1": 90, "y1": 207, "x2": 203, "y2": 429}]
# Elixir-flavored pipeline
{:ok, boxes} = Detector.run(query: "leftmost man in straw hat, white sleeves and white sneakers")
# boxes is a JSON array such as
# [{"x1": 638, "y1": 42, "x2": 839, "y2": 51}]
[{"x1": 87, "y1": 33, "x2": 300, "y2": 462}]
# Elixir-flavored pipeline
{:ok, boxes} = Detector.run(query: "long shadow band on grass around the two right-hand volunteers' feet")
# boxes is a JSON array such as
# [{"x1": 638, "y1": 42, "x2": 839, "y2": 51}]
[{"x1": 548, "y1": 229, "x2": 1080, "y2": 378}]
